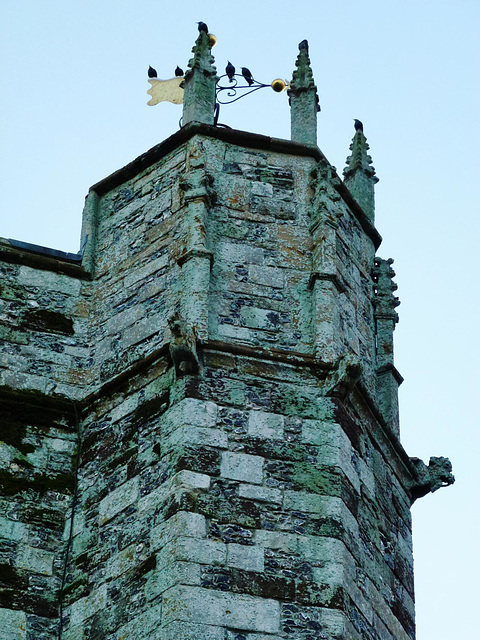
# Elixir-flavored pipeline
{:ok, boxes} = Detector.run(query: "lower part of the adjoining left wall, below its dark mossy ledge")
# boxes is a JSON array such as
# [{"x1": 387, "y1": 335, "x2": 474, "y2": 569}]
[{"x1": 0, "y1": 387, "x2": 77, "y2": 640}]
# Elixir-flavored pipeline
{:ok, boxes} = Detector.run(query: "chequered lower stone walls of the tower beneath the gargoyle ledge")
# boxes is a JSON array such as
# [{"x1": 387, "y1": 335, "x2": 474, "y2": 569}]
[{"x1": 59, "y1": 351, "x2": 413, "y2": 640}]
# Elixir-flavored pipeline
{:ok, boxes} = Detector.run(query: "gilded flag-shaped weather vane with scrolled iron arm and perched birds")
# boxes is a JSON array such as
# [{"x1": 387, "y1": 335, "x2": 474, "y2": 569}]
[{"x1": 147, "y1": 22, "x2": 289, "y2": 126}]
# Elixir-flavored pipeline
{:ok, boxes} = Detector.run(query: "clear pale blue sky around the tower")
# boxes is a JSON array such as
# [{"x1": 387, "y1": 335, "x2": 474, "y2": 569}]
[{"x1": 0, "y1": 0, "x2": 480, "y2": 640}]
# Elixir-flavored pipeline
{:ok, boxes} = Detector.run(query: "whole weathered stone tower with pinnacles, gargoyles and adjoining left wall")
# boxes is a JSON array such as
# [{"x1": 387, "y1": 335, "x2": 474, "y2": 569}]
[{"x1": 0, "y1": 32, "x2": 453, "y2": 640}]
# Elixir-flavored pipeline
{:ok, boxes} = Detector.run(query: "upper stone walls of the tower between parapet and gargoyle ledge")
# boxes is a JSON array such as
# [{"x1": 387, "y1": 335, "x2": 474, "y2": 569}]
[{"x1": 83, "y1": 137, "x2": 375, "y2": 392}]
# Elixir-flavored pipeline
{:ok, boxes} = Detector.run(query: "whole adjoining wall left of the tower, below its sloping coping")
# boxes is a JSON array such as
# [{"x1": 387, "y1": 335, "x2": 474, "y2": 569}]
[{"x1": 0, "y1": 254, "x2": 88, "y2": 640}]
